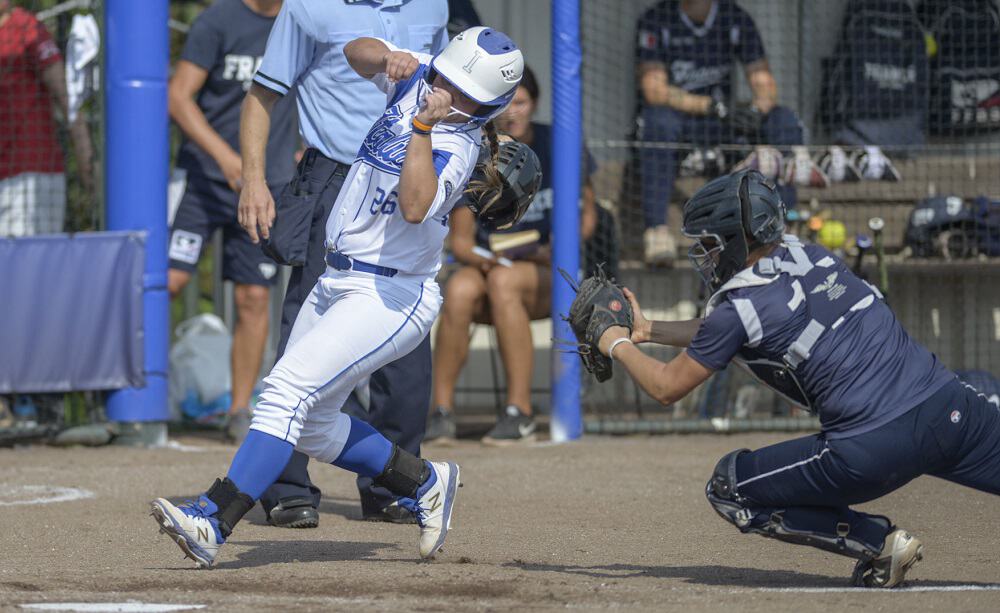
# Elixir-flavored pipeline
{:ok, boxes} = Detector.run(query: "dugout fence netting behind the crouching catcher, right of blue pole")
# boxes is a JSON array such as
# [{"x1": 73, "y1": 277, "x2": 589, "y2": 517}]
[{"x1": 580, "y1": 0, "x2": 1000, "y2": 432}]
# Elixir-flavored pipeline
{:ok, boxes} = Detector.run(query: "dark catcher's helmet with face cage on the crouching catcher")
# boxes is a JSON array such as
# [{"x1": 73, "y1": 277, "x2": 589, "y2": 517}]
[{"x1": 681, "y1": 169, "x2": 785, "y2": 291}]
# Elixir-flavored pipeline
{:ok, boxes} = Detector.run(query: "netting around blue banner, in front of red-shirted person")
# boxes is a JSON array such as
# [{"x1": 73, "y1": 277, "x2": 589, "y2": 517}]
[{"x1": 0, "y1": 0, "x2": 105, "y2": 445}]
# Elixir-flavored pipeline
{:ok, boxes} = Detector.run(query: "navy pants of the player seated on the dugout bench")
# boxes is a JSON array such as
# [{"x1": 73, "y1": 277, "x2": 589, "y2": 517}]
[{"x1": 639, "y1": 106, "x2": 804, "y2": 228}]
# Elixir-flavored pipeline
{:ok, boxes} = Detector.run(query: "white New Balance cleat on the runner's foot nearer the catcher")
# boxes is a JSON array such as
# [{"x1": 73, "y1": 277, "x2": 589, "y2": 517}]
[{"x1": 400, "y1": 462, "x2": 461, "y2": 559}]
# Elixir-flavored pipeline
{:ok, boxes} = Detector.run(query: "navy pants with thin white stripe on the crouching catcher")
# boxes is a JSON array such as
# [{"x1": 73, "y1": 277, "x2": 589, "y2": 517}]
[{"x1": 736, "y1": 379, "x2": 1000, "y2": 542}]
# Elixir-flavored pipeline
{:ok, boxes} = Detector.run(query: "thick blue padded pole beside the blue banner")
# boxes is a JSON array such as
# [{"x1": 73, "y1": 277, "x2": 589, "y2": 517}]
[{"x1": 104, "y1": 0, "x2": 170, "y2": 422}]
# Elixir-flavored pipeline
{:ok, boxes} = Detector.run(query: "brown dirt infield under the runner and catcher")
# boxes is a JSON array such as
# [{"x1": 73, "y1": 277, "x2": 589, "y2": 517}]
[{"x1": 0, "y1": 435, "x2": 1000, "y2": 612}]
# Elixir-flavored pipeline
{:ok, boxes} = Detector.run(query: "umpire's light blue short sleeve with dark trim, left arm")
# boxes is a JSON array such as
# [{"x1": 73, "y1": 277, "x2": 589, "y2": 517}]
[{"x1": 253, "y1": 2, "x2": 316, "y2": 96}]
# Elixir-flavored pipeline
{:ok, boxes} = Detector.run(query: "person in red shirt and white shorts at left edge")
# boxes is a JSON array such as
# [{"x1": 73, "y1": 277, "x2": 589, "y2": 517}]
[{"x1": 0, "y1": 0, "x2": 93, "y2": 237}]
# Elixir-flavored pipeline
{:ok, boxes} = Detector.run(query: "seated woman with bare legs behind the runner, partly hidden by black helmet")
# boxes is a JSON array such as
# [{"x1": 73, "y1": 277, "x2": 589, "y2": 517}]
[{"x1": 424, "y1": 66, "x2": 597, "y2": 445}]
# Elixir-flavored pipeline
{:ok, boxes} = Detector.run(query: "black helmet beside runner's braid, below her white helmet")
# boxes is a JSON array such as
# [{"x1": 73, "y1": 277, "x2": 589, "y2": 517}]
[{"x1": 466, "y1": 141, "x2": 542, "y2": 230}]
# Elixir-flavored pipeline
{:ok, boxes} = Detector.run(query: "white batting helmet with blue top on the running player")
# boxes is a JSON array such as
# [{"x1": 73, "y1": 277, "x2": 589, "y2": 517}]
[{"x1": 427, "y1": 27, "x2": 524, "y2": 125}]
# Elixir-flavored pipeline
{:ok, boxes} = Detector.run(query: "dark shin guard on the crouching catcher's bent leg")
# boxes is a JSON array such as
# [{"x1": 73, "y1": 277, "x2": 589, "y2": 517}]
[{"x1": 705, "y1": 449, "x2": 892, "y2": 560}]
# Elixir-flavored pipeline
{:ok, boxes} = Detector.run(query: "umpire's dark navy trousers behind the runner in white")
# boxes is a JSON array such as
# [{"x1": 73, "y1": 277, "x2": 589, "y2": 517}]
[{"x1": 260, "y1": 149, "x2": 431, "y2": 513}]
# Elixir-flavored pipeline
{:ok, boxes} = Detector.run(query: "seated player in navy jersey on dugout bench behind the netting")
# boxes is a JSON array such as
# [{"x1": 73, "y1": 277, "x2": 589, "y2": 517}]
[{"x1": 636, "y1": 0, "x2": 803, "y2": 265}]
